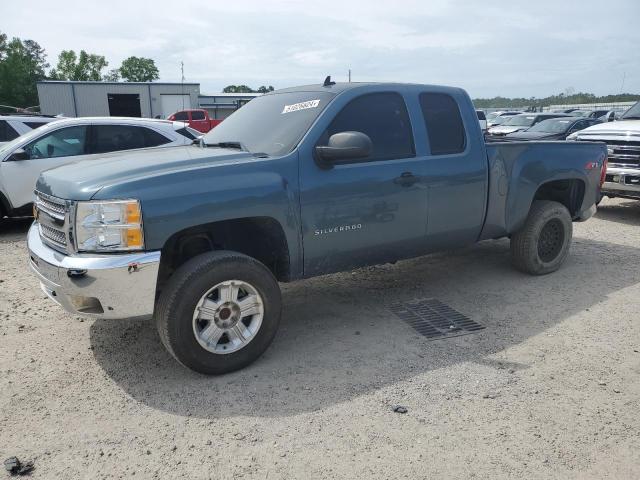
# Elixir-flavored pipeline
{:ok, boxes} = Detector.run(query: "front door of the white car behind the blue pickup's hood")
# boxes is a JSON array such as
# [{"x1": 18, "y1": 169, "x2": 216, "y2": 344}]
[{"x1": 0, "y1": 125, "x2": 88, "y2": 208}]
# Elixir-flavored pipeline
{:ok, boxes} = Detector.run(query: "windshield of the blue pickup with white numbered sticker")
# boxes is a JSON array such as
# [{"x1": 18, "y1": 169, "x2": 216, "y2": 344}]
[{"x1": 203, "y1": 92, "x2": 335, "y2": 156}]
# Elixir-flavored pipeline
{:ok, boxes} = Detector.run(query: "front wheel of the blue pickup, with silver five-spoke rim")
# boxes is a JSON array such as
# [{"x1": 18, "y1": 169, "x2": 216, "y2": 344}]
[{"x1": 155, "y1": 251, "x2": 282, "y2": 375}]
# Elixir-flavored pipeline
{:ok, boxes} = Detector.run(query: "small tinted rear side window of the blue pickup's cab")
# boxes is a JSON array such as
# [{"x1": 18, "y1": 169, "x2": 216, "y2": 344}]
[{"x1": 420, "y1": 93, "x2": 466, "y2": 155}]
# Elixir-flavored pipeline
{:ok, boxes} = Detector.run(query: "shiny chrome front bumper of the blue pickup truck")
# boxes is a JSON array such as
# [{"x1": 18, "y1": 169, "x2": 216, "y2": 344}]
[{"x1": 27, "y1": 223, "x2": 160, "y2": 318}]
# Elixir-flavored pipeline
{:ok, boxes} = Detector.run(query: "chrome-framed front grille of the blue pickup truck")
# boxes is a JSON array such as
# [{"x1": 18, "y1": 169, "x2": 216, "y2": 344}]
[{"x1": 35, "y1": 192, "x2": 69, "y2": 253}]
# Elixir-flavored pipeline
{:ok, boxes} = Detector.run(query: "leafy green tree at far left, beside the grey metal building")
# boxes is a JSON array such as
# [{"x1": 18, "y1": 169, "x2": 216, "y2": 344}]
[{"x1": 0, "y1": 34, "x2": 49, "y2": 108}]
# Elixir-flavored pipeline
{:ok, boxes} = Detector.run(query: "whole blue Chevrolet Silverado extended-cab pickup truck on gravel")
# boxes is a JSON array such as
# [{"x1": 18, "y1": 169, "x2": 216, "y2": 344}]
[{"x1": 28, "y1": 79, "x2": 606, "y2": 374}]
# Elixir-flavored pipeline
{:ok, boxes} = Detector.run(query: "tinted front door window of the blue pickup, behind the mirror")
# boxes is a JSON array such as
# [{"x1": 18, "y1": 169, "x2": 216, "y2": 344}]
[{"x1": 319, "y1": 93, "x2": 415, "y2": 161}]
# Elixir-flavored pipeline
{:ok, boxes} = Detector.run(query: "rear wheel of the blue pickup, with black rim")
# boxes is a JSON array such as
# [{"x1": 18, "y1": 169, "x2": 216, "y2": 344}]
[{"x1": 511, "y1": 200, "x2": 573, "y2": 275}]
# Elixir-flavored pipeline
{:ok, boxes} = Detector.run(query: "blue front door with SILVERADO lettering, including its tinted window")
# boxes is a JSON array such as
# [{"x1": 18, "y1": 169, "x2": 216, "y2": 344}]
[{"x1": 300, "y1": 92, "x2": 427, "y2": 276}]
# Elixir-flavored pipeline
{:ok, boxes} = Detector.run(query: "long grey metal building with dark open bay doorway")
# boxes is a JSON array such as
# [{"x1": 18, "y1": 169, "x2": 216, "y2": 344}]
[{"x1": 37, "y1": 81, "x2": 200, "y2": 118}]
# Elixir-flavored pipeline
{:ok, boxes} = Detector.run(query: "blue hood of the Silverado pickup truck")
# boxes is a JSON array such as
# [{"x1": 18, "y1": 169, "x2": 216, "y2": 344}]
[{"x1": 36, "y1": 145, "x2": 257, "y2": 200}]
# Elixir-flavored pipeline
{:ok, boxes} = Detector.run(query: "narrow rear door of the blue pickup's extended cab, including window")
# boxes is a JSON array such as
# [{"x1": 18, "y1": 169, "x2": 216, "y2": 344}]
[{"x1": 419, "y1": 92, "x2": 488, "y2": 250}]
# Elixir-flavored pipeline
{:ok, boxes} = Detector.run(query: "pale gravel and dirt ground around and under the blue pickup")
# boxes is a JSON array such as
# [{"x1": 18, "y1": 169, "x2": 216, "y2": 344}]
[{"x1": 0, "y1": 199, "x2": 640, "y2": 480}]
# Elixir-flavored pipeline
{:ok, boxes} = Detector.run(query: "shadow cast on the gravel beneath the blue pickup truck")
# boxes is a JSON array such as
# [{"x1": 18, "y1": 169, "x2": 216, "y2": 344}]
[{"x1": 90, "y1": 238, "x2": 640, "y2": 419}]
